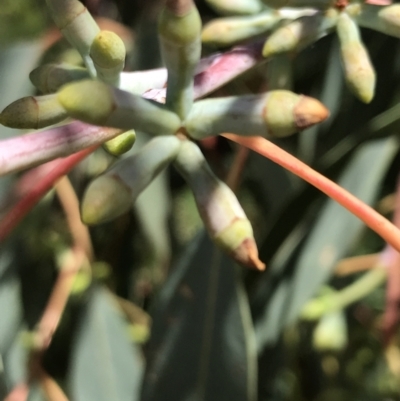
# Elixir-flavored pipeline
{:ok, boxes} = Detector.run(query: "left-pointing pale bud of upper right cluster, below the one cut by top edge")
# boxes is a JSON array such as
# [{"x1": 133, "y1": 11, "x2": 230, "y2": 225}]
[{"x1": 201, "y1": 11, "x2": 281, "y2": 46}]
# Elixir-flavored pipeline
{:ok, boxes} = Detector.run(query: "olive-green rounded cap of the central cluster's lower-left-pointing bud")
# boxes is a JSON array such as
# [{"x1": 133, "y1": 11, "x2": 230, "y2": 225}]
[{"x1": 81, "y1": 175, "x2": 132, "y2": 225}]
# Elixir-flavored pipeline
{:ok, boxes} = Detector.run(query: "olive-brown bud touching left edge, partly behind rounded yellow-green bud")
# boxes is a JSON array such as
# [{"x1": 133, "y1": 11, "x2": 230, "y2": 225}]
[{"x1": 0, "y1": 94, "x2": 68, "y2": 129}]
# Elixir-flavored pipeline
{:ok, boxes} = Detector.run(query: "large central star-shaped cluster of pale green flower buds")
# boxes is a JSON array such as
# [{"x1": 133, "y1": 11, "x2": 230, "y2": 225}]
[{"x1": 0, "y1": 0, "x2": 334, "y2": 269}]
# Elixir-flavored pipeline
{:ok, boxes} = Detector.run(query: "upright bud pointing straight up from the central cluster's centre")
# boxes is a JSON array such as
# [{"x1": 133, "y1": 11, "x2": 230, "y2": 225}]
[{"x1": 158, "y1": 0, "x2": 201, "y2": 118}]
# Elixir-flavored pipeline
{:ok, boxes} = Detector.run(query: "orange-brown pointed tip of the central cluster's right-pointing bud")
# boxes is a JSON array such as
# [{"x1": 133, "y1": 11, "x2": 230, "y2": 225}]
[{"x1": 293, "y1": 96, "x2": 329, "y2": 130}]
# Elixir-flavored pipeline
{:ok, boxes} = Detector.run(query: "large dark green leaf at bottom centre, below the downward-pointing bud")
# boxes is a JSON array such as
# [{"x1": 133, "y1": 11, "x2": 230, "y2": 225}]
[{"x1": 142, "y1": 232, "x2": 256, "y2": 401}]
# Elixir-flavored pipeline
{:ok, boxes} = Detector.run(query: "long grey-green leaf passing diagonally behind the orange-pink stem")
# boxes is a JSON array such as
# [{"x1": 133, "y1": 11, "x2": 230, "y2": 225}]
[{"x1": 255, "y1": 138, "x2": 398, "y2": 350}]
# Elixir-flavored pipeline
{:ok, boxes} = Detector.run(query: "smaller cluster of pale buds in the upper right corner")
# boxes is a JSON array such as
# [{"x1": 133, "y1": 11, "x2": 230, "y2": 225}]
[{"x1": 202, "y1": 0, "x2": 400, "y2": 103}]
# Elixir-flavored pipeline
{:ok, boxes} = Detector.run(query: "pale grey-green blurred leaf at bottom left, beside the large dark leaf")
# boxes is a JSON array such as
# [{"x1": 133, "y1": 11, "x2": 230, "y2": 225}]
[{"x1": 68, "y1": 286, "x2": 143, "y2": 401}]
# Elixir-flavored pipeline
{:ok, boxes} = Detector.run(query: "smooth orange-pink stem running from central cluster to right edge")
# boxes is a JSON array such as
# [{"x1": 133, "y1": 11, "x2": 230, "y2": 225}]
[{"x1": 223, "y1": 134, "x2": 400, "y2": 251}]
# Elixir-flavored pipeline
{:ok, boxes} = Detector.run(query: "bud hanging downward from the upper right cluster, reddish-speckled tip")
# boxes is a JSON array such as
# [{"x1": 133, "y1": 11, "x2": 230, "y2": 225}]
[{"x1": 337, "y1": 12, "x2": 376, "y2": 103}]
